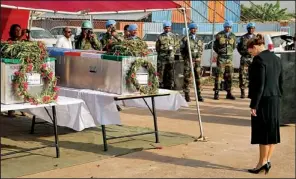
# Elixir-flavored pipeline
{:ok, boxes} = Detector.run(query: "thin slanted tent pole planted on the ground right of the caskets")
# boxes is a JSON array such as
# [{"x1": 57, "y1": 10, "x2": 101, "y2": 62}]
[{"x1": 182, "y1": 8, "x2": 206, "y2": 141}]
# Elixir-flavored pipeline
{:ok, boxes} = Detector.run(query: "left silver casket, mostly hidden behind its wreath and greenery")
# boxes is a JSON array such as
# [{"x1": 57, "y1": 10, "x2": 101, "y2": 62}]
[{"x1": 1, "y1": 58, "x2": 55, "y2": 104}]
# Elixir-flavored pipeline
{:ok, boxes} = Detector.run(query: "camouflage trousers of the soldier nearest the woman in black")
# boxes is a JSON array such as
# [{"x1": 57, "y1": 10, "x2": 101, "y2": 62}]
[{"x1": 239, "y1": 56, "x2": 252, "y2": 89}]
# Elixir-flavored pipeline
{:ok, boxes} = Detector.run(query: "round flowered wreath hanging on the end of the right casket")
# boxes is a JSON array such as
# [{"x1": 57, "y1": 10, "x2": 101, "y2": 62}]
[{"x1": 126, "y1": 59, "x2": 159, "y2": 94}]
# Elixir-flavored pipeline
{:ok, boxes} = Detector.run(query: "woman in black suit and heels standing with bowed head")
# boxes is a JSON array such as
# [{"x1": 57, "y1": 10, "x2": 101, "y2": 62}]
[{"x1": 247, "y1": 34, "x2": 283, "y2": 174}]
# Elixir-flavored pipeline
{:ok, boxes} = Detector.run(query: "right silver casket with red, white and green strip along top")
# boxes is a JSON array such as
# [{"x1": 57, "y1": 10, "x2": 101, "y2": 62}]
[{"x1": 49, "y1": 49, "x2": 157, "y2": 94}]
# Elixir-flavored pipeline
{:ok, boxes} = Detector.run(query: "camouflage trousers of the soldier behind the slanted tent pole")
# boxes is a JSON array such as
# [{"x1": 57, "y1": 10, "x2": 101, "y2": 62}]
[{"x1": 183, "y1": 58, "x2": 201, "y2": 93}]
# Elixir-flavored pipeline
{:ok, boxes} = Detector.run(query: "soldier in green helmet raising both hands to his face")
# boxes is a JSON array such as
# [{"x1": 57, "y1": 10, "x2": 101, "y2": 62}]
[{"x1": 75, "y1": 21, "x2": 101, "y2": 50}]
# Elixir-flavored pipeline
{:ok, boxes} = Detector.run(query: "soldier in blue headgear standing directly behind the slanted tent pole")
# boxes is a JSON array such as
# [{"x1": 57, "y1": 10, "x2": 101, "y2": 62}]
[{"x1": 181, "y1": 23, "x2": 204, "y2": 102}]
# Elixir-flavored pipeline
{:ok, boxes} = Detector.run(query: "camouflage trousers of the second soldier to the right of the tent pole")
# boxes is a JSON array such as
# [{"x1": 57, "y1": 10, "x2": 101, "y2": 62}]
[{"x1": 214, "y1": 56, "x2": 234, "y2": 91}]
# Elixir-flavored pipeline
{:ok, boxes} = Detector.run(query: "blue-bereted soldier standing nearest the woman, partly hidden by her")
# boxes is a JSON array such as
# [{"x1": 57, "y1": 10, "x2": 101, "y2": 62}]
[{"x1": 237, "y1": 23, "x2": 255, "y2": 98}]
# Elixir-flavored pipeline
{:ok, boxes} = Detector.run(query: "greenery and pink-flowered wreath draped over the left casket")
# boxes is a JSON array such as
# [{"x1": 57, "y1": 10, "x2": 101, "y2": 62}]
[{"x1": 1, "y1": 41, "x2": 59, "y2": 105}]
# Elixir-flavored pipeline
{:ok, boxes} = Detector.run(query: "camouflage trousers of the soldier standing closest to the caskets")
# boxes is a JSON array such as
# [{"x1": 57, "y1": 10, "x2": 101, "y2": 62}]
[{"x1": 157, "y1": 62, "x2": 175, "y2": 90}]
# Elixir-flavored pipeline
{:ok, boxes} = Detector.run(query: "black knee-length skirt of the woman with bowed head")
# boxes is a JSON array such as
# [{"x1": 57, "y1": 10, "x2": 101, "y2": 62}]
[{"x1": 251, "y1": 96, "x2": 281, "y2": 145}]
